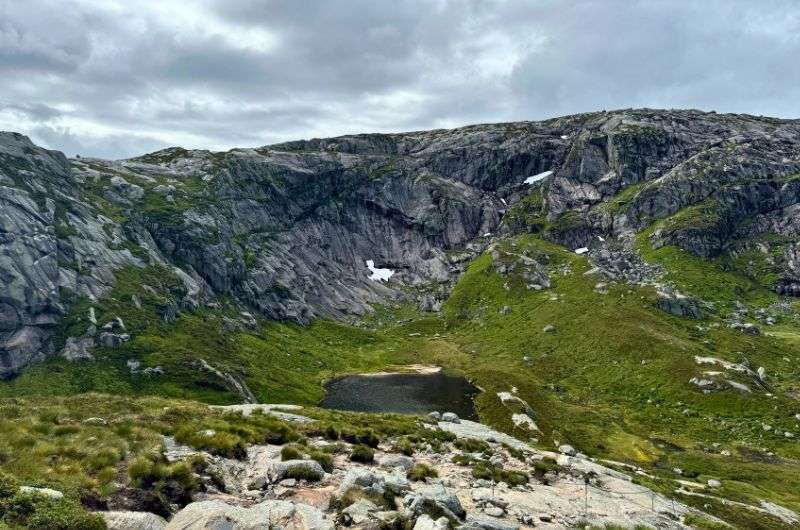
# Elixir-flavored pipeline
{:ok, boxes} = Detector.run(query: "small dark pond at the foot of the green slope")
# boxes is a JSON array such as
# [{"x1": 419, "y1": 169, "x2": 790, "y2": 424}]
[{"x1": 321, "y1": 372, "x2": 478, "y2": 420}]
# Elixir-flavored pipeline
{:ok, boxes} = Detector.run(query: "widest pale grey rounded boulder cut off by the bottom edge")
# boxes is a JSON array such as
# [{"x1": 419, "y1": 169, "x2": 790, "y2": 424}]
[{"x1": 165, "y1": 500, "x2": 334, "y2": 530}]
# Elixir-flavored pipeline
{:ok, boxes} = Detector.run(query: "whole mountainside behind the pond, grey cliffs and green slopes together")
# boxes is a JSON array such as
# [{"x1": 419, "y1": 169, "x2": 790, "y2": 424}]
[{"x1": 0, "y1": 106, "x2": 800, "y2": 528}]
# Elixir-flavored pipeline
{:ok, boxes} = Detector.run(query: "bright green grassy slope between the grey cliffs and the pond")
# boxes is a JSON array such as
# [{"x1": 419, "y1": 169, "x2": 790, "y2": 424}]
[{"x1": 0, "y1": 236, "x2": 800, "y2": 528}]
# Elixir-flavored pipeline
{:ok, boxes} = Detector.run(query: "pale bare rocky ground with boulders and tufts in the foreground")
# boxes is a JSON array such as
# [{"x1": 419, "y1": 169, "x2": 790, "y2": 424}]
[{"x1": 84, "y1": 405, "x2": 728, "y2": 530}]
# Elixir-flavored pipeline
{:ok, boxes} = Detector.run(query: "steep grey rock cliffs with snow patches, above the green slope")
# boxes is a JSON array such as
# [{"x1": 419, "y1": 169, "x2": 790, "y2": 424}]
[{"x1": 0, "y1": 110, "x2": 800, "y2": 376}]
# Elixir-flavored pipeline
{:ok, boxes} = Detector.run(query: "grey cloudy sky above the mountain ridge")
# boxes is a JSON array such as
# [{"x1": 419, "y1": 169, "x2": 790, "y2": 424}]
[{"x1": 0, "y1": 0, "x2": 800, "y2": 158}]
